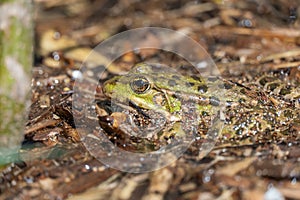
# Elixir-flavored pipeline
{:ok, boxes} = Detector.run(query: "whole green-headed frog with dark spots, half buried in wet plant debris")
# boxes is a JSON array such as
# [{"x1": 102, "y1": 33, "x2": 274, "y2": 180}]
[{"x1": 103, "y1": 63, "x2": 299, "y2": 149}]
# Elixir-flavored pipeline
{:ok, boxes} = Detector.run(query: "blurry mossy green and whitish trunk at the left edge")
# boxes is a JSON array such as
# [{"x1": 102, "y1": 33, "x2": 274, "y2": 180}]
[{"x1": 0, "y1": 0, "x2": 33, "y2": 164}]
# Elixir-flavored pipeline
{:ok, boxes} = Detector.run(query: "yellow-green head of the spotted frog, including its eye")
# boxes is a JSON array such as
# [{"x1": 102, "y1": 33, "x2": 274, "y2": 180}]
[{"x1": 103, "y1": 63, "x2": 179, "y2": 112}]
